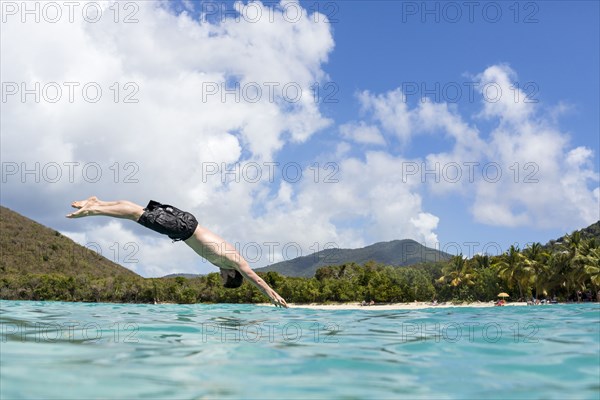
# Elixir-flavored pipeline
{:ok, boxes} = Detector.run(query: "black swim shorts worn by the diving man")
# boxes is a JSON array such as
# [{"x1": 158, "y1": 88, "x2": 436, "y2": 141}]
[{"x1": 138, "y1": 200, "x2": 198, "y2": 242}]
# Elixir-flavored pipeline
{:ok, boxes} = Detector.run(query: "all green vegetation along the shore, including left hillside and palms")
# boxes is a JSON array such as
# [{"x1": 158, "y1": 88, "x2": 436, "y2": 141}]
[{"x1": 0, "y1": 208, "x2": 600, "y2": 303}]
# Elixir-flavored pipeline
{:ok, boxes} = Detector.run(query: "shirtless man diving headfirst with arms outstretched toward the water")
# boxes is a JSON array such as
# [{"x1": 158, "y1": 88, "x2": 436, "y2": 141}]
[{"x1": 67, "y1": 197, "x2": 288, "y2": 307}]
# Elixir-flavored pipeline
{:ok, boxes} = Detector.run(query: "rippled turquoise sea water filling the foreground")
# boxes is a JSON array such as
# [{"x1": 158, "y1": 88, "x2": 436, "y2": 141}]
[{"x1": 0, "y1": 301, "x2": 600, "y2": 400}]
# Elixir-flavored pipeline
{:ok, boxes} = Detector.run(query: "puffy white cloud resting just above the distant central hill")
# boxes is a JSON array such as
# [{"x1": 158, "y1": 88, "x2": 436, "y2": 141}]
[{"x1": 244, "y1": 151, "x2": 438, "y2": 260}]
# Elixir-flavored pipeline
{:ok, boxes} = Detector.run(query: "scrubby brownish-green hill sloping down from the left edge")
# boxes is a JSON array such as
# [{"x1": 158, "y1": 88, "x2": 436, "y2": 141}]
[{"x1": 0, "y1": 206, "x2": 143, "y2": 300}]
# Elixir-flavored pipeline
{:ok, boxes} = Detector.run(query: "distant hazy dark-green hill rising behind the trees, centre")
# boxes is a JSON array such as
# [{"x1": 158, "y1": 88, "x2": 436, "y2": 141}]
[{"x1": 256, "y1": 239, "x2": 451, "y2": 278}]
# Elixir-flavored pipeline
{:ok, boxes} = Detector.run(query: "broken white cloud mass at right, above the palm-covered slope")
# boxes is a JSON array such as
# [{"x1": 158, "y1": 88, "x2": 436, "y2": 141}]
[{"x1": 353, "y1": 65, "x2": 600, "y2": 231}]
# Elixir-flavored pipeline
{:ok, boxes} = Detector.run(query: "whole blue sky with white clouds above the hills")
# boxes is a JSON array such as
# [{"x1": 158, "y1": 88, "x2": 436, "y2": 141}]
[{"x1": 1, "y1": 1, "x2": 600, "y2": 276}]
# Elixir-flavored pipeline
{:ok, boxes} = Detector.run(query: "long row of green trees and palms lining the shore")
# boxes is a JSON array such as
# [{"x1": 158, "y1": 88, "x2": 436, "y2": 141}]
[{"x1": 0, "y1": 232, "x2": 600, "y2": 304}]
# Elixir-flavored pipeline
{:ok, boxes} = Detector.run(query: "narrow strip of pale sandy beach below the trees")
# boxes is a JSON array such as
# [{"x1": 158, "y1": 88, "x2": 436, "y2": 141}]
[{"x1": 286, "y1": 302, "x2": 527, "y2": 311}]
